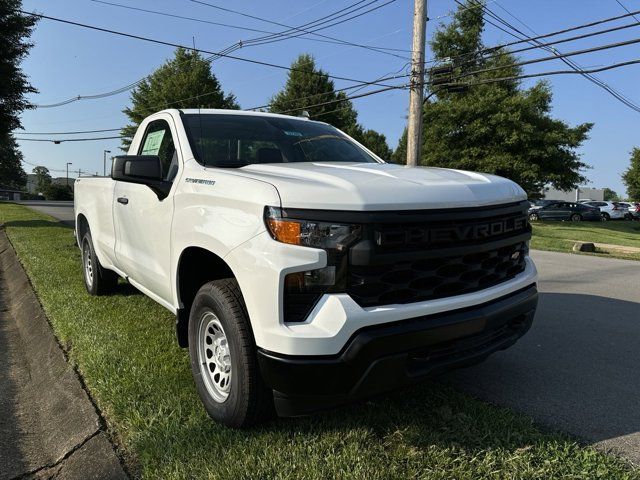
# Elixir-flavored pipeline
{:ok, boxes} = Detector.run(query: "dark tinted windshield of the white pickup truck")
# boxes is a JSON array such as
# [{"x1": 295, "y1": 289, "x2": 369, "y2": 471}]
[{"x1": 182, "y1": 114, "x2": 378, "y2": 168}]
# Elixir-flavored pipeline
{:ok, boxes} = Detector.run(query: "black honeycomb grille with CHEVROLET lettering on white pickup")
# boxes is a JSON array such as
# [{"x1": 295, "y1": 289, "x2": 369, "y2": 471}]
[{"x1": 347, "y1": 203, "x2": 531, "y2": 307}]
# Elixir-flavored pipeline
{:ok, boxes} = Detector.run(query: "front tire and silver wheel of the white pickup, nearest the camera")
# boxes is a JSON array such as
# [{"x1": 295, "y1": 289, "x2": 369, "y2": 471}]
[{"x1": 189, "y1": 279, "x2": 273, "y2": 428}]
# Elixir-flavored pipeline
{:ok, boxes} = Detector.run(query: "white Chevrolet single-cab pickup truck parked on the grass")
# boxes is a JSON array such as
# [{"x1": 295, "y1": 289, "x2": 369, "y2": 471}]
[{"x1": 75, "y1": 110, "x2": 537, "y2": 427}]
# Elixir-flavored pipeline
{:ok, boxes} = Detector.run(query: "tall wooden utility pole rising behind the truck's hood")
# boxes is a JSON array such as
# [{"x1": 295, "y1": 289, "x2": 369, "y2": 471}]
[{"x1": 407, "y1": 0, "x2": 428, "y2": 167}]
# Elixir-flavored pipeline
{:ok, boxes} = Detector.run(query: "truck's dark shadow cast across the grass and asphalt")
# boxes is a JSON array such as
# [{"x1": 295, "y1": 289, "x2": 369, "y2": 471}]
[{"x1": 122, "y1": 293, "x2": 640, "y2": 478}]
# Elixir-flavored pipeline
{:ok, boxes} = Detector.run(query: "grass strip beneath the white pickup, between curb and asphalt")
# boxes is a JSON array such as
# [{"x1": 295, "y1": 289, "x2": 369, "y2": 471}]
[{"x1": 0, "y1": 204, "x2": 640, "y2": 480}]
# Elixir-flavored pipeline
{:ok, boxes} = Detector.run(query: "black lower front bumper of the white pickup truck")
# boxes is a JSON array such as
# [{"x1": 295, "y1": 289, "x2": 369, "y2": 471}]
[{"x1": 258, "y1": 284, "x2": 538, "y2": 416}]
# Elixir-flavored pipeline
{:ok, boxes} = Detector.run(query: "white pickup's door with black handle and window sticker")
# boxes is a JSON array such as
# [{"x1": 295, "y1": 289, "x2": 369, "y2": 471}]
[{"x1": 113, "y1": 116, "x2": 181, "y2": 303}]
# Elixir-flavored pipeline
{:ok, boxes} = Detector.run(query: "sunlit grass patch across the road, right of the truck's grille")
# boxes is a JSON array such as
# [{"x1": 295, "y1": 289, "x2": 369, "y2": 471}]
[{"x1": 531, "y1": 221, "x2": 640, "y2": 260}]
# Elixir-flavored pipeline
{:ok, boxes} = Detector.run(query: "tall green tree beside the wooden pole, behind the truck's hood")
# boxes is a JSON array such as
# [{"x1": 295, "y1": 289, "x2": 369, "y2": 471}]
[{"x1": 393, "y1": 0, "x2": 593, "y2": 195}]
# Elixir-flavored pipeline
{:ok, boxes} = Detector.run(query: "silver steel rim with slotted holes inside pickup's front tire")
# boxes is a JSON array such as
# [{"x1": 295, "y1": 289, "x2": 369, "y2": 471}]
[{"x1": 198, "y1": 312, "x2": 232, "y2": 403}]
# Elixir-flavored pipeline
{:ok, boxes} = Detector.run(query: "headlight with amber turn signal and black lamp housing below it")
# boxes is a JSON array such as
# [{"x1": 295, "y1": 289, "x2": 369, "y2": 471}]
[{"x1": 265, "y1": 207, "x2": 361, "y2": 322}]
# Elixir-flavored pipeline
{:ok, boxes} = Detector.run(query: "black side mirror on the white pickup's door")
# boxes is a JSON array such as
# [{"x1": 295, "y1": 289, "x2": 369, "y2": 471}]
[{"x1": 111, "y1": 155, "x2": 171, "y2": 200}]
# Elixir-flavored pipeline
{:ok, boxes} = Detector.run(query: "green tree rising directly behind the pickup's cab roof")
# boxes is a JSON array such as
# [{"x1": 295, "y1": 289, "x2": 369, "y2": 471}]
[{"x1": 121, "y1": 48, "x2": 240, "y2": 150}]
